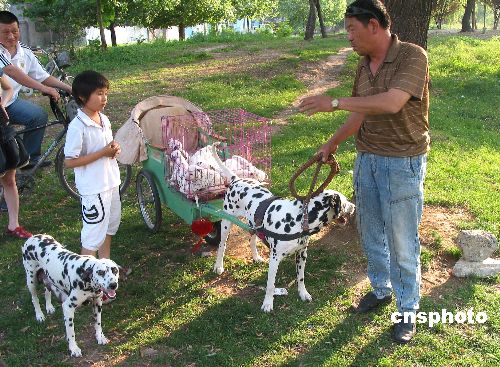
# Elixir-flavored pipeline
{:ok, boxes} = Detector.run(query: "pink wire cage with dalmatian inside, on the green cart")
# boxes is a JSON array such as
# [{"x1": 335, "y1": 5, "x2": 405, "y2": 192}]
[{"x1": 161, "y1": 109, "x2": 271, "y2": 200}]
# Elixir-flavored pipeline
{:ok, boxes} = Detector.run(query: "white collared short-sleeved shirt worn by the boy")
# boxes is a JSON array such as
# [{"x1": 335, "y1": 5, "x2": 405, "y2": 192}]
[{"x1": 64, "y1": 109, "x2": 121, "y2": 195}]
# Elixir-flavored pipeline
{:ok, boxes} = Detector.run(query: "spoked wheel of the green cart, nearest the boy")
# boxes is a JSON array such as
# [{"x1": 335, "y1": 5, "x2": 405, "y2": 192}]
[{"x1": 135, "y1": 170, "x2": 162, "y2": 232}]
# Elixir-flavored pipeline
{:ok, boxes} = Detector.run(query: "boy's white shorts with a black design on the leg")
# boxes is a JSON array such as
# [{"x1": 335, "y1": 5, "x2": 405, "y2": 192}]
[{"x1": 81, "y1": 186, "x2": 122, "y2": 251}]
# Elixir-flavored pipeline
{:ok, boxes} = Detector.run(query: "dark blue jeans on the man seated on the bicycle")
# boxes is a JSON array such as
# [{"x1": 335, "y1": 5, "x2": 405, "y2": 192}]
[{"x1": 7, "y1": 98, "x2": 49, "y2": 162}]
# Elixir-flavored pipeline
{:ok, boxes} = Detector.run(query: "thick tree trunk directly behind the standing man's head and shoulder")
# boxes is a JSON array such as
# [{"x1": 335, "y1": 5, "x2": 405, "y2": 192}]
[{"x1": 384, "y1": 0, "x2": 433, "y2": 49}]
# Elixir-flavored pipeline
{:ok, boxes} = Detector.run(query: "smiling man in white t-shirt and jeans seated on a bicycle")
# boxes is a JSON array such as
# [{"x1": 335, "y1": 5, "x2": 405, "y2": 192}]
[{"x1": 0, "y1": 11, "x2": 71, "y2": 168}]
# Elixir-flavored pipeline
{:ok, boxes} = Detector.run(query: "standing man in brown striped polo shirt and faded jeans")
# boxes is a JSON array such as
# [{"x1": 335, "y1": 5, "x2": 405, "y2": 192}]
[{"x1": 300, "y1": 0, "x2": 430, "y2": 343}]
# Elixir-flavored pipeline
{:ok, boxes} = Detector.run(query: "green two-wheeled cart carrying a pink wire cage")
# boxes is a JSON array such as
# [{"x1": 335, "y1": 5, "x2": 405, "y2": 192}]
[{"x1": 128, "y1": 97, "x2": 271, "y2": 246}]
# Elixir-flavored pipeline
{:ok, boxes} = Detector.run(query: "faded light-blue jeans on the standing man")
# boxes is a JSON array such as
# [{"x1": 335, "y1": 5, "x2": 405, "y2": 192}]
[{"x1": 354, "y1": 152, "x2": 427, "y2": 312}]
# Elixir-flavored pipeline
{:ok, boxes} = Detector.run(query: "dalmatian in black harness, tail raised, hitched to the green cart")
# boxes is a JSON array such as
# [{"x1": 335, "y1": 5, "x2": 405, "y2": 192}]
[{"x1": 212, "y1": 146, "x2": 355, "y2": 312}]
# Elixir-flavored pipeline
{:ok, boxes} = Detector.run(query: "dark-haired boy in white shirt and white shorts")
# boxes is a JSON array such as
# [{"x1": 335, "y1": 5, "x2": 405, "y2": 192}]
[{"x1": 64, "y1": 70, "x2": 121, "y2": 302}]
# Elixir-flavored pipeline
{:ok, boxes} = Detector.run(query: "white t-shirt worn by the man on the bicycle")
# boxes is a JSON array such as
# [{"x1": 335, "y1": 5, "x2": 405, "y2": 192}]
[{"x1": 0, "y1": 42, "x2": 50, "y2": 106}]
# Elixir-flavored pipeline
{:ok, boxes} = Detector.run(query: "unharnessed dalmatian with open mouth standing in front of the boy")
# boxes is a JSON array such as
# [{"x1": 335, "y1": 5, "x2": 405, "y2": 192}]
[{"x1": 22, "y1": 234, "x2": 119, "y2": 357}]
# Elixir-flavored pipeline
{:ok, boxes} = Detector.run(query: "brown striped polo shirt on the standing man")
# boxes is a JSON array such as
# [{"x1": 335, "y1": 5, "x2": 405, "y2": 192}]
[{"x1": 352, "y1": 34, "x2": 430, "y2": 157}]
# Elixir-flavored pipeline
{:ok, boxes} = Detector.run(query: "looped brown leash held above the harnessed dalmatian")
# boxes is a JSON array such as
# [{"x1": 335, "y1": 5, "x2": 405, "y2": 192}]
[{"x1": 288, "y1": 153, "x2": 340, "y2": 232}]
